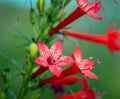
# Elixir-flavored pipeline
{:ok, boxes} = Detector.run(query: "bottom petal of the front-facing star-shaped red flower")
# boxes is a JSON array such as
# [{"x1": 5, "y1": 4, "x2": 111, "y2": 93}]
[{"x1": 49, "y1": 65, "x2": 62, "y2": 77}]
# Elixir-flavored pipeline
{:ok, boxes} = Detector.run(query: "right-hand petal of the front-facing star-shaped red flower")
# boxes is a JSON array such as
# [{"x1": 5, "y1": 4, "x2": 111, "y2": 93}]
[{"x1": 58, "y1": 55, "x2": 74, "y2": 66}]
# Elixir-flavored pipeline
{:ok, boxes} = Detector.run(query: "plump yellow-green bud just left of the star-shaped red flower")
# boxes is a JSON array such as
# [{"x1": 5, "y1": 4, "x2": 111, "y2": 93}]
[{"x1": 29, "y1": 42, "x2": 38, "y2": 58}]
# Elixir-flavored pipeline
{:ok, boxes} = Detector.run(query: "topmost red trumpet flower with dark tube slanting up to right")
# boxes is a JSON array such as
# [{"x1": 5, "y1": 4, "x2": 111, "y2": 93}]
[{"x1": 49, "y1": 0, "x2": 102, "y2": 35}]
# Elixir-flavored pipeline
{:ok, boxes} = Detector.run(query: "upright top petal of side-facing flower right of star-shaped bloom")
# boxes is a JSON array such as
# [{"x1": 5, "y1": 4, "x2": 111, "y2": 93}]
[{"x1": 72, "y1": 46, "x2": 82, "y2": 64}]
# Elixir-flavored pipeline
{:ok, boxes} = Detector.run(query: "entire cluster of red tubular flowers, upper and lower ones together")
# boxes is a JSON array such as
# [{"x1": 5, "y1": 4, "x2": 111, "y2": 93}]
[{"x1": 31, "y1": 0, "x2": 120, "y2": 99}]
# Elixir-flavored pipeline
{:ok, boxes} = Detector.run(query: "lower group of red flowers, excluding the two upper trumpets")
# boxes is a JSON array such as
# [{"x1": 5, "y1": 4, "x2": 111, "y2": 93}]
[{"x1": 31, "y1": 41, "x2": 98, "y2": 99}]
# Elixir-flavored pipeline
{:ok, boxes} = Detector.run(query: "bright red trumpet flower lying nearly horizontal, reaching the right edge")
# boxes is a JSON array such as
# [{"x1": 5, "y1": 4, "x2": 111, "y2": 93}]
[{"x1": 62, "y1": 24, "x2": 120, "y2": 53}]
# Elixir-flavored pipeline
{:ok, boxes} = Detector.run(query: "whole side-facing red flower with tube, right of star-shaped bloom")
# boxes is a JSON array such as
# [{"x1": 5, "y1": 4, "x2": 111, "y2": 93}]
[{"x1": 39, "y1": 47, "x2": 98, "y2": 86}]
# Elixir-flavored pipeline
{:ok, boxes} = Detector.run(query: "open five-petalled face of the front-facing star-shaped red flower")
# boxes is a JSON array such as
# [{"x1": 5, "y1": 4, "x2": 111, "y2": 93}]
[{"x1": 35, "y1": 41, "x2": 73, "y2": 76}]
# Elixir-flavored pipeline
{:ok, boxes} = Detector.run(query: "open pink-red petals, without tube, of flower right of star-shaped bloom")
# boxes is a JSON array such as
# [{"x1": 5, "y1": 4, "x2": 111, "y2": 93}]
[{"x1": 73, "y1": 46, "x2": 98, "y2": 79}]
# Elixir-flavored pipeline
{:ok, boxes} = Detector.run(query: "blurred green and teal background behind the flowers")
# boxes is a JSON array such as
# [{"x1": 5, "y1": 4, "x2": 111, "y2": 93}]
[{"x1": 0, "y1": 0, "x2": 120, "y2": 99}]
